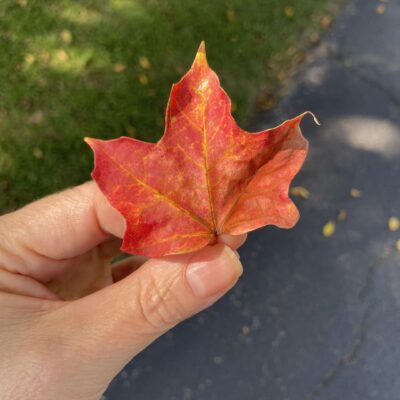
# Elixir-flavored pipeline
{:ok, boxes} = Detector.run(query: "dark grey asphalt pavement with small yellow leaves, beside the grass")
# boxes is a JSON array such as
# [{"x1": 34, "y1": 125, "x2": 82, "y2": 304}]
[{"x1": 104, "y1": 0, "x2": 400, "y2": 400}]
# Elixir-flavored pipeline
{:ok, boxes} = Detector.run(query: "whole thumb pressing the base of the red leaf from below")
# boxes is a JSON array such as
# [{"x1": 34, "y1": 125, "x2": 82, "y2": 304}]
[{"x1": 53, "y1": 244, "x2": 243, "y2": 396}]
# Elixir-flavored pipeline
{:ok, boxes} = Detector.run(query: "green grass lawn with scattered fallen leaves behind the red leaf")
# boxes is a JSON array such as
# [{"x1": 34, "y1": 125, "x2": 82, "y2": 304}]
[{"x1": 0, "y1": 0, "x2": 338, "y2": 211}]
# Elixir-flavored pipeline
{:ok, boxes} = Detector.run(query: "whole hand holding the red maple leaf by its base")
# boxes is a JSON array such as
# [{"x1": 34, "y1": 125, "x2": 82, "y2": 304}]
[{"x1": 0, "y1": 182, "x2": 245, "y2": 400}]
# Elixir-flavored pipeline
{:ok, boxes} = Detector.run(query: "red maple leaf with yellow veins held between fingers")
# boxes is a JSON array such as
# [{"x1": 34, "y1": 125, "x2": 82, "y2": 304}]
[{"x1": 85, "y1": 43, "x2": 308, "y2": 257}]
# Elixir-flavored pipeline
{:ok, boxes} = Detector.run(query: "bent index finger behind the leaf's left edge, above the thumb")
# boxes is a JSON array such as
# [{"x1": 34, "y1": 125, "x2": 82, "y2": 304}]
[{"x1": 0, "y1": 182, "x2": 125, "y2": 281}]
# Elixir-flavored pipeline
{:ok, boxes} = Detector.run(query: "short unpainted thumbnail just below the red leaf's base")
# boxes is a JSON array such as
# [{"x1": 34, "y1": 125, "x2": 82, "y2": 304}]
[{"x1": 186, "y1": 244, "x2": 243, "y2": 297}]
